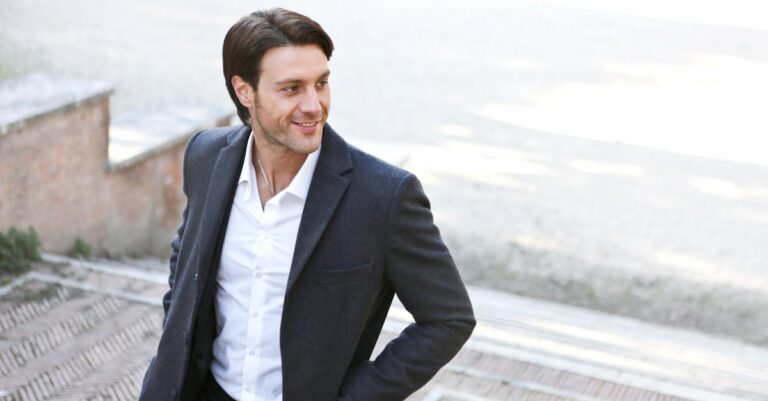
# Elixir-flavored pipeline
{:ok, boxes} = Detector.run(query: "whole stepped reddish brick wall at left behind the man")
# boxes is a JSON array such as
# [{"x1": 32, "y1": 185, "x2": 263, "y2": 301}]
[{"x1": 0, "y1": 83, "x2": 212, "y2": 257}]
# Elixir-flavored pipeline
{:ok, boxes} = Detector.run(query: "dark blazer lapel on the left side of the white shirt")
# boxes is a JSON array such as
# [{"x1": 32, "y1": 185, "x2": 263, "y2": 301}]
[{"x1": 196, "y1": 126, "x2": 250, "y2": 298}]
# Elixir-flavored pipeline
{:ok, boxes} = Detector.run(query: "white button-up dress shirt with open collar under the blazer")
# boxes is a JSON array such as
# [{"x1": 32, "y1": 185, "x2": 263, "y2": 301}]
[{"x1": 211, "y1": 134, "x2": 320, "y2": 401}]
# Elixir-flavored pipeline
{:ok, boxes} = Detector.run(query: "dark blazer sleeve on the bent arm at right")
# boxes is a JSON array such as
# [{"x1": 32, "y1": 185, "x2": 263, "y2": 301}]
[{"x1": 339, "y1": 174, "x2": 475, "y2": 401}]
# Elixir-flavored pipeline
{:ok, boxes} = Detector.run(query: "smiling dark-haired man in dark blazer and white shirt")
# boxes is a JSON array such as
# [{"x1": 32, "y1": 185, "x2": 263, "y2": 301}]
[{"x1": 140, "y1": 9, "x2": 475, "y2": 401}]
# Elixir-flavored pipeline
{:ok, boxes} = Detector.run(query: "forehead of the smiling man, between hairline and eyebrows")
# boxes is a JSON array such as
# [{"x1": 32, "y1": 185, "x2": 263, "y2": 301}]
[{"x1": 260, "y1": 45, "x2": 328, "y2": 83}]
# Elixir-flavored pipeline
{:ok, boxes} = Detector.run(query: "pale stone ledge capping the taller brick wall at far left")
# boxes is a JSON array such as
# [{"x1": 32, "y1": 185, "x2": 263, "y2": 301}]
[{"x1": 0, "y1": 73, "x2": 114, "y2": 136}]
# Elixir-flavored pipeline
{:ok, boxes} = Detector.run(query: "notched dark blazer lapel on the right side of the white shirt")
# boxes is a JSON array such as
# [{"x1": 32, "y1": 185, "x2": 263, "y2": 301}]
[{"x1": 286, "y1": 124, "x2": 352, "y2": 294}]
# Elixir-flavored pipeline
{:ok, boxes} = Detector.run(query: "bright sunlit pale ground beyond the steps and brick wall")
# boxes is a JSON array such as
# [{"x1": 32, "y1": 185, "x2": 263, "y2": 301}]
[{"x1": 0, "y1": 0, "x2": 768, "y2": 344}]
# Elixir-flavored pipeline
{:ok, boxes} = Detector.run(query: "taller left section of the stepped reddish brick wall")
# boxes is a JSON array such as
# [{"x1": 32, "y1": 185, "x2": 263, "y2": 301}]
[{"x1": 0, "y1": 95, "x2": 109, "y2": 252}]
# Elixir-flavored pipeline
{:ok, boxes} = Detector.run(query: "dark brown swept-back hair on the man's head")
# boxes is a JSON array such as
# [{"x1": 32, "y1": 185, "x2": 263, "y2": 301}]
[{"x1": 222, "y1": 8, "x2": 333, "y2": 125}]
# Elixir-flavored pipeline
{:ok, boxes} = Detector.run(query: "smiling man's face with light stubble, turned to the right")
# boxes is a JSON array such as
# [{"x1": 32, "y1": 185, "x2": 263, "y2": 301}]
[{"x1": 233, "y1": 45, "x2": 331, "y2": 155}]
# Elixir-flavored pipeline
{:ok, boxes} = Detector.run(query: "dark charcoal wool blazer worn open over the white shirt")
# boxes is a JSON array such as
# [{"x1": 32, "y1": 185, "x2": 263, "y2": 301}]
[{"x1": 140, "y1": 125, "x2": 475, "y2": 401}]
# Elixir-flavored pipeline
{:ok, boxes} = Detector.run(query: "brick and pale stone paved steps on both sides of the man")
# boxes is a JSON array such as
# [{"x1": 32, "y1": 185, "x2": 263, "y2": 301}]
[{"x1": 0, "y1": 256, "x2": 768, "y2": 401}]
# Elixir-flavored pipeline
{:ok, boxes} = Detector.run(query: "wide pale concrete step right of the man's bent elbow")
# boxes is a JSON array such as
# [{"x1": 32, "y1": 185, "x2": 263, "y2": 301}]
[{"x1": 387, "y1": 288, "x2": 768, "y2": 401}]
